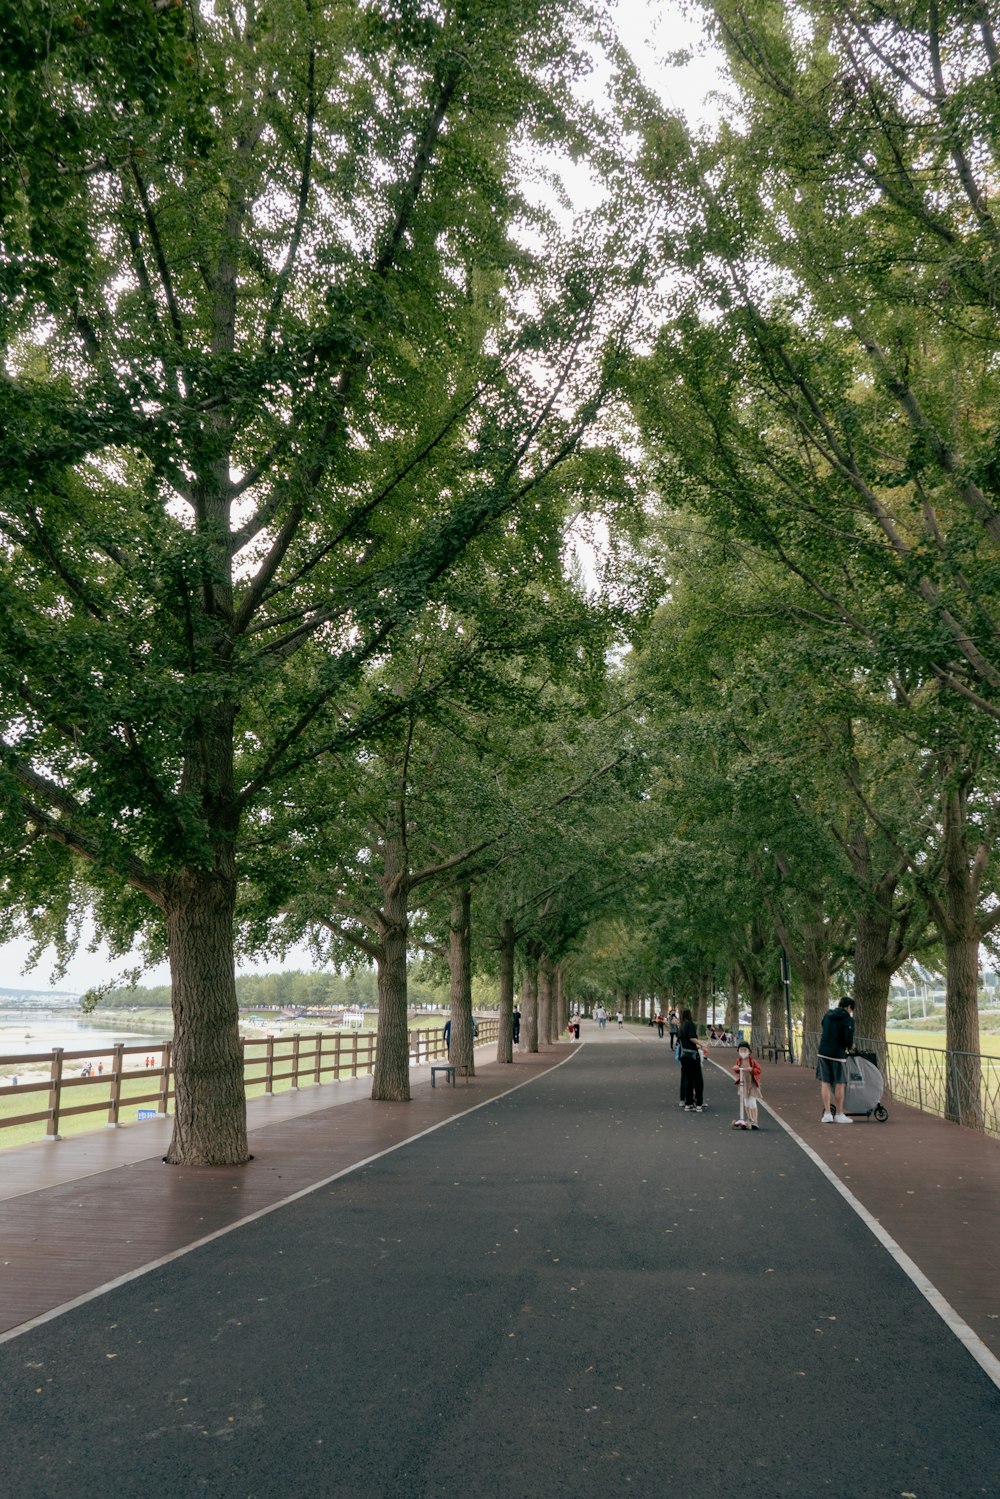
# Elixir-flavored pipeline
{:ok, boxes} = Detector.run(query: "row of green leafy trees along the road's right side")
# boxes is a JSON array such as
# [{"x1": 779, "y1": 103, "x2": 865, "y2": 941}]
[{"x1": 587, "y1": 0, "x2": 1000, "y2": 1114}]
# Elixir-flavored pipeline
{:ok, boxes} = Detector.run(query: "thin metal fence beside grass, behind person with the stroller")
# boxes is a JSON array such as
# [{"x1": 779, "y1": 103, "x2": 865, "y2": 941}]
[{"x1": 802, "y1": 1036, "x2": 1000, "y2": 1139}]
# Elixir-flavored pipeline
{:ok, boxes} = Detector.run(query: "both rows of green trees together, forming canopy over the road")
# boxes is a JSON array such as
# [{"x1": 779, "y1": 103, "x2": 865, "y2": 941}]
[{"x1": 0, "y1": 0, "x2": 1000, "y2": 1163}]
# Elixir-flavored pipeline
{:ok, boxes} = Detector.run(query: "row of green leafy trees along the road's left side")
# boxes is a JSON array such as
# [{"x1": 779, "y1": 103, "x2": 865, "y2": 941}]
[{"x1": 0, "y1": 0, "x2": 656, "y2": 1163}]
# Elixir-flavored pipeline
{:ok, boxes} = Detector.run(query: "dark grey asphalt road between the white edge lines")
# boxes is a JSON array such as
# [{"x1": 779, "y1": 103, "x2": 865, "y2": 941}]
[{"x1": 0, "y1": 1042, "x2": 1000, "y2": 1499}]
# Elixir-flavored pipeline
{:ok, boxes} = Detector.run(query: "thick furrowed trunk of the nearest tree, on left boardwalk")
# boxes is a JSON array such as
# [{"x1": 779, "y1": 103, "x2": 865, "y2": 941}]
[{"x1": 163, "y1": 854, "x2": 249, "y2": 1166}]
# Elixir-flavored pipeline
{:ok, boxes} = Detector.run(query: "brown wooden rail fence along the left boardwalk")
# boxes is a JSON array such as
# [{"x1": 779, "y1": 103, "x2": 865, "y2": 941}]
[{"x1": 0, "y1": 1018, "x2": 499, "y2": 1139}]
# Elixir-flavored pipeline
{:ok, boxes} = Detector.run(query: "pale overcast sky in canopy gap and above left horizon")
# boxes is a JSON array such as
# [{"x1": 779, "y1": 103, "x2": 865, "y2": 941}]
[{"x1": 0, "y1": 0, "x2": 718, "y2": 992}]
